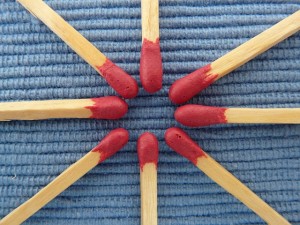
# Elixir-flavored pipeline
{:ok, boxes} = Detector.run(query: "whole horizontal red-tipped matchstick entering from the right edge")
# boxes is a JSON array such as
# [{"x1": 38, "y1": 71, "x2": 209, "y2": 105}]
[{"x1": 174, "y1": 104, "x2": 300, "y2": 127}]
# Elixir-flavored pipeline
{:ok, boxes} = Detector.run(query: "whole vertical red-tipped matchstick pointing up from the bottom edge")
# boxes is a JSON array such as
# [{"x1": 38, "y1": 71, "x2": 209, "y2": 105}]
[{"x1": 137, "y1": 132, "x2": 158, "y2": 225}]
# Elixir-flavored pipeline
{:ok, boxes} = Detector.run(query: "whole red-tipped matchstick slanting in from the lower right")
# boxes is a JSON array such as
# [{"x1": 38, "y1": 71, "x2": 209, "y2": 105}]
[{"x1": 165, "y1": 127, "x2": 290, "y2": 225}]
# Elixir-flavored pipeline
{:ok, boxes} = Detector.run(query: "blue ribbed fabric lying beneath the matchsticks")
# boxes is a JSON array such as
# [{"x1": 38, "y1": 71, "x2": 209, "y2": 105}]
[{"x1": 0, "y1": 0, "x2": 300, "y2": 225}]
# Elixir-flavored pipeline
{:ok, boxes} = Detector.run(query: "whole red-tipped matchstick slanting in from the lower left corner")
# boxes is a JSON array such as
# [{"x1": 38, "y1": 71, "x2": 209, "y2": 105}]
[{"x1": 0, "y1": 128, "x2": 129, "y2": 225}]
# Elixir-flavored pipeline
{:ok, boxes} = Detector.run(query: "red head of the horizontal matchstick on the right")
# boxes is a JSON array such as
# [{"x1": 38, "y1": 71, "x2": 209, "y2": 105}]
[{"x1": 174, "y1": 104, "x2": 227, "y2": 127}]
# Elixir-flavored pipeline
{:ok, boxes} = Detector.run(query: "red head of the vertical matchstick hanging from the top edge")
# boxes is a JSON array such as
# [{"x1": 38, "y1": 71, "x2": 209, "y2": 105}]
[{"x1": 140, "y1": 38, "x2": 163, "y2": 93}]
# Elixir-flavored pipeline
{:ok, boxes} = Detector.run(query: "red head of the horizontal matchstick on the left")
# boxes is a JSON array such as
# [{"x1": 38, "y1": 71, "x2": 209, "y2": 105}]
[{"x1": 85, "y1": 96, "x2": 128, "y2": 120}]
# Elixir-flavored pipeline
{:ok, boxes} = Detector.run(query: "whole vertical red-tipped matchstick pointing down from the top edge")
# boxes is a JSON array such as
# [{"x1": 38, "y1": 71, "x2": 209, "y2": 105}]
[{"x1": 140, "y1": 0, "x2": 163, "y2": 93}]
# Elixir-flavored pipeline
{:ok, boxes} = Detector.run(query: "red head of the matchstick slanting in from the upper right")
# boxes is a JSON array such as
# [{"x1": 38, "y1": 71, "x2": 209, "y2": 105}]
[{"x1": 169, "y1": 64, "x2": 218, "y2": 104}]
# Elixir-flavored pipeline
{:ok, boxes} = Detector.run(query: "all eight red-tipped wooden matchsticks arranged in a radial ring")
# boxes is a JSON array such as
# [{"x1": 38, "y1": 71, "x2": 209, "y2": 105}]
[{"x1": 0, "y1": 0, "x2": 300, "y2": 225}]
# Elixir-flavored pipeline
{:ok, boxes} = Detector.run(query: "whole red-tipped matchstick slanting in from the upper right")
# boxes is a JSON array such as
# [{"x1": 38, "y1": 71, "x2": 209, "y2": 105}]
[{"x1": 169, "y1": 10, "x2": 300, "y2": 104}]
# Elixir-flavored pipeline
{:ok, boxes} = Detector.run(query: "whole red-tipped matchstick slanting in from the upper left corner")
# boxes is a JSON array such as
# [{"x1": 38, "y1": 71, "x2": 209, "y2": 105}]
[{"x1": 17, "y1": 0, "x2": 138, "y2": 98}]
